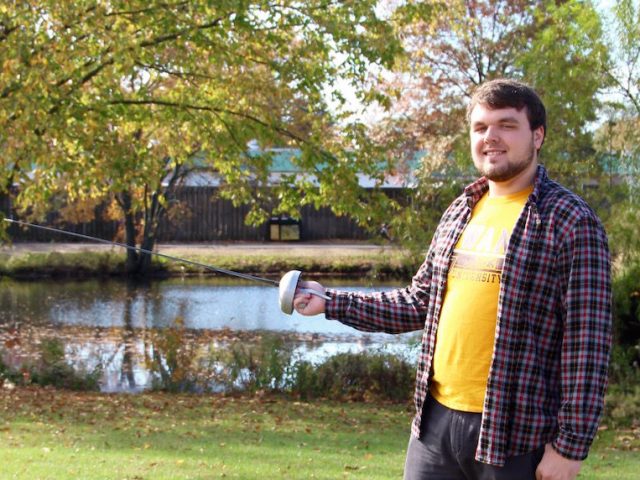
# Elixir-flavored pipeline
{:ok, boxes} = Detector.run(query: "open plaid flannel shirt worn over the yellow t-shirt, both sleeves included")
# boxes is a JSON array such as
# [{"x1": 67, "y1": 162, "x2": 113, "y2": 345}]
[{"x1": 326, "y1": 166, "x2": 611, "y2": 465}]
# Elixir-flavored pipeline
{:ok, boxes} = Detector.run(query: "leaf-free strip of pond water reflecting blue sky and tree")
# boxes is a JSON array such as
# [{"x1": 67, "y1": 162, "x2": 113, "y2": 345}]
[{"x1": 0, "y1": 278, "x2": 404, "y2": 335}]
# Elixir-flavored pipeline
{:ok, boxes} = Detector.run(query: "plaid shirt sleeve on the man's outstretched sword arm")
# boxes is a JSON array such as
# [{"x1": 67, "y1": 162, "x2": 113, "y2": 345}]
[{"x1": 325, "y1": 248, "x2": 433, "y2": 333}]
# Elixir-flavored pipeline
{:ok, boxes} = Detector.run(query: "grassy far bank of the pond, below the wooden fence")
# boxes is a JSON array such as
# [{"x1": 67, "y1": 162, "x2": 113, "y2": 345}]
[{"x1": 0, "y1": 246, "x2": 420, "y2": 278}]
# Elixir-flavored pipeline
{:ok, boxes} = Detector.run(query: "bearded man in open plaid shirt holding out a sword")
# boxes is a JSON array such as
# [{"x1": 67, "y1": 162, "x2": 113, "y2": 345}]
[{"x1": 294, "y1": 80, "x2": 611, "y2": 480}]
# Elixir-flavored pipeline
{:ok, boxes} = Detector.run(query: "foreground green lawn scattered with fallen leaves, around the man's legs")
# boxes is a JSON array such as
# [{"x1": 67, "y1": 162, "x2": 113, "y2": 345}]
[{"x1": 0, "y1": 388, "x2": 640, "y2": 480}]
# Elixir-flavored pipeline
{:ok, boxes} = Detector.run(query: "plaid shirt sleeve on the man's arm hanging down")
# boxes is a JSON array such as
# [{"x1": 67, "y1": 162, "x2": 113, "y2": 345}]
[{"x1": 553, "y1": 216, "x2": 612, "y2": 460}]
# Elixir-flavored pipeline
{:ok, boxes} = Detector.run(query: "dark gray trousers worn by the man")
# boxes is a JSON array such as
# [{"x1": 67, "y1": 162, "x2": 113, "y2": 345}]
[{"x1": 404, "y1": 395, "x2": 544, "y2": 480}]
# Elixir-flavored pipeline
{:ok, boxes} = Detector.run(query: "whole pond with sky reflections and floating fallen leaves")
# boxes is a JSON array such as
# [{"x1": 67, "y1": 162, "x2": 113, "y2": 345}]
[{"x1": 0, "y1": 277, "x2": 420, "y2": 392}]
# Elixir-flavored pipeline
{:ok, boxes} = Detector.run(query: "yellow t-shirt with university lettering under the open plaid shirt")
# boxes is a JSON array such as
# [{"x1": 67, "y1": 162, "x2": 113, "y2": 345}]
[{"x1": 430, "y1": 187, "x2": 533, "y2": 412}]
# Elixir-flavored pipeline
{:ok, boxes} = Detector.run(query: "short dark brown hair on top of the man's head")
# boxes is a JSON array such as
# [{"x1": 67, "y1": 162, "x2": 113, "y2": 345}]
[{"x1": 467, "y1": 78, "x2": 547, "y2": 140}]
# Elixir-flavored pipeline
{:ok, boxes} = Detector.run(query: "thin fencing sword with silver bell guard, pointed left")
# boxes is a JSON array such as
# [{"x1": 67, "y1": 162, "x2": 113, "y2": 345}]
[{"x1": 3, "y1": 218, "x2": 331, "y2": 315}]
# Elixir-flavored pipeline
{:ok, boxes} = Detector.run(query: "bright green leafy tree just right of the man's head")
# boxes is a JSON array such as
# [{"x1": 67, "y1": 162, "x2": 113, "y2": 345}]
[{"x1": 517, "y1": 1, "x2": 609, "y2": 183}]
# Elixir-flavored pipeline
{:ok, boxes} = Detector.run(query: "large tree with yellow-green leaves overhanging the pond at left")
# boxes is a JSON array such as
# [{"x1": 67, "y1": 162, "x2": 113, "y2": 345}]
[{"x1": 0, "y1": 0, "x2": 399, "y2": 271}]
